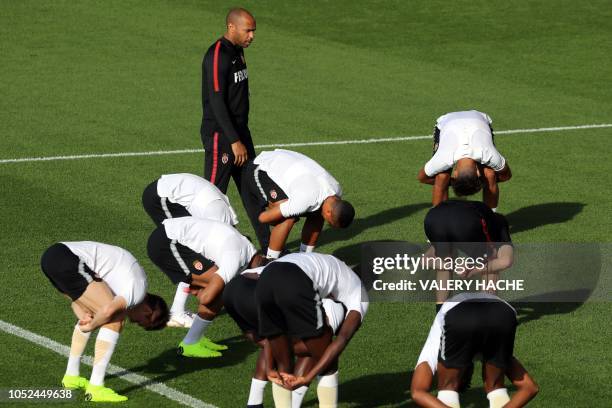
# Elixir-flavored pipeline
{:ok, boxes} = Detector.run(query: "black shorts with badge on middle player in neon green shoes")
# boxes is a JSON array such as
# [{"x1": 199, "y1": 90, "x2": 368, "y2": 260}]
[{"x1": 147, "y1": 225, "x2": 214, "y2": 285}]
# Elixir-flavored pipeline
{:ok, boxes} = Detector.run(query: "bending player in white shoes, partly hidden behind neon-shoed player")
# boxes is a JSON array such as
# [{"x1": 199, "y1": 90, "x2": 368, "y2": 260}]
[{"x1": 142, "y1": 173, "x2": 238, "y2": 328}]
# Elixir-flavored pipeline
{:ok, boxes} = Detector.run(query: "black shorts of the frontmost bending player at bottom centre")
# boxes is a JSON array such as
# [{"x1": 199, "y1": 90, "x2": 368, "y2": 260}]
[{"x1": 255, "y1": 261, "x2": 325, "y2": 339}]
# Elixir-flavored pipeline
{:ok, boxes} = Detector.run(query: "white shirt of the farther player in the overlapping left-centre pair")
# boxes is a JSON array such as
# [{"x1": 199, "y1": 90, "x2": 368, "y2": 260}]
[{"x1": 157, "y1": 173, "x2": 238, "y2": 225}]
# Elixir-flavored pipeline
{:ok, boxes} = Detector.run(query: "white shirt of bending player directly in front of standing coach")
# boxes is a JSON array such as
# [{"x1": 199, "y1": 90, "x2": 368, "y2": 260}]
[{"x1": 254, "y1": 149, "x2": 342, "y2": 218}]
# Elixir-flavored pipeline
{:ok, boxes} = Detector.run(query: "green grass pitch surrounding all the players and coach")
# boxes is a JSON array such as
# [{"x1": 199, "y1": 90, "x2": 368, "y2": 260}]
[{"x1": 0, "y1": 0, "x2": 612, "y2": 407}]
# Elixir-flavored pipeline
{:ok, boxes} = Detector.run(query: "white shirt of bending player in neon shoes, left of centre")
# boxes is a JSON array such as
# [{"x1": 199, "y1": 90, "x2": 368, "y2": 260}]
[{"x1": 163, "y1": 217, "x2": 257, "y2": 283}]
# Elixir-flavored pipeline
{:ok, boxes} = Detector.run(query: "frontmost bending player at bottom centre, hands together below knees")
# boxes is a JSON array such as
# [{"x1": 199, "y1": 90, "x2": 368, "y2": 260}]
[{"x1": 255, "y1": 253, "x2": 368, "y2": 408}]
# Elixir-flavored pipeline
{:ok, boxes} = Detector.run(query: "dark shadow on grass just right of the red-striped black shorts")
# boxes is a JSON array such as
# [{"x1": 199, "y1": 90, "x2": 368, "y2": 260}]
[{"x1": 506, "y1": 202, "x2": 586, "y2": 234}]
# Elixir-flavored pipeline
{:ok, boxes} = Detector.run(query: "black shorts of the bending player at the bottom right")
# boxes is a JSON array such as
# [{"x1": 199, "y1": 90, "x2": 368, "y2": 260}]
[{"x1": 438, "y1": 300, "x2": 517, "y2": 369}]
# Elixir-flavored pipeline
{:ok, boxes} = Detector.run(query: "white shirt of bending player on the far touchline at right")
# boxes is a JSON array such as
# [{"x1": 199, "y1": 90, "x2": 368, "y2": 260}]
[{"x1": 425, "y1": 110, "x2": 506, "y2": 177}]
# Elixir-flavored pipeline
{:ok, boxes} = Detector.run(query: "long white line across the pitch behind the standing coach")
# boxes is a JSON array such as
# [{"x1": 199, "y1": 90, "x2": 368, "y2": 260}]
[{"x1": 0, "y1": 123, "x2": 612, "y2": 164}]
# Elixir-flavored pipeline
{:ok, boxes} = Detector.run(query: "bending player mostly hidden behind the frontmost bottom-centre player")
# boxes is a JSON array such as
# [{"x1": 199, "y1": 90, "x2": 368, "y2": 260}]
[{"x1": 223, "y1": 268, "x2": 346, "y2": 408}]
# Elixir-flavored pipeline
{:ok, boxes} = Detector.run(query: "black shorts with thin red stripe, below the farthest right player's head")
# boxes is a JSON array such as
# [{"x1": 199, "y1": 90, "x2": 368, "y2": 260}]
[{"x1": 424, "y1": 200, "x2": 512, "y2": 258}]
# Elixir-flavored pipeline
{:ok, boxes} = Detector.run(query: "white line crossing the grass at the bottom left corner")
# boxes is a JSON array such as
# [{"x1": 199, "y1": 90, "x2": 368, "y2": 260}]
[{"x1": 0, "y1": 320, "x2": 216, "y2": 408}]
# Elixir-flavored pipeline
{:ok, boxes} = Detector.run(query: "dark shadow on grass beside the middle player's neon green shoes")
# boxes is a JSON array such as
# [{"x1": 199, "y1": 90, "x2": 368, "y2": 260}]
[{"x1": 107, "y1": 336, "x2": 257, "y2": 394}]
